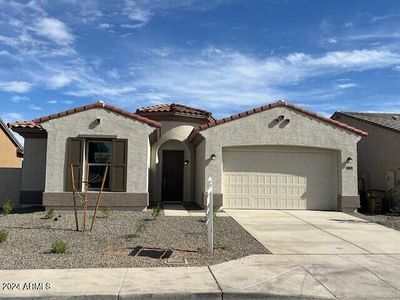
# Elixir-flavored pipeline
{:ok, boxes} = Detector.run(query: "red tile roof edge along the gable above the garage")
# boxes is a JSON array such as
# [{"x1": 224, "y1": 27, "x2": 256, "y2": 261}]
[{"x1": 191, "y1": 101, "x2": 368, "y2": 138}]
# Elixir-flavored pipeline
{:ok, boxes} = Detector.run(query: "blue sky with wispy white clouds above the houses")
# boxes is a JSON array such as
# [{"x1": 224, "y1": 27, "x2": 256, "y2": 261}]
[{"x1": 0, "y1": 0, "x2": 400, "y2": 129}]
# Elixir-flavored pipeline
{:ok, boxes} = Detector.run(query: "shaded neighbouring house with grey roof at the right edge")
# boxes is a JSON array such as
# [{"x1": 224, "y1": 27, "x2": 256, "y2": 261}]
[{"x1": 332, "y1": 112, "x2": 400, "y2": 192}]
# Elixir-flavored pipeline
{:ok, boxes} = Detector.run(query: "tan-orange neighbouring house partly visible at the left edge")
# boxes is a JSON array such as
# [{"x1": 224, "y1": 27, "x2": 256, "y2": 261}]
[{"x1": 0, "y1": 119, "x2": 23, "y2": 168}]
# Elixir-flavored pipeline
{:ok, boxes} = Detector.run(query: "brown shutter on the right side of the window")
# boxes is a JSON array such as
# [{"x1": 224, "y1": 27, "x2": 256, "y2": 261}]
[{"x1": 110, "y1": 139, "x2": 128, "y2": 192}]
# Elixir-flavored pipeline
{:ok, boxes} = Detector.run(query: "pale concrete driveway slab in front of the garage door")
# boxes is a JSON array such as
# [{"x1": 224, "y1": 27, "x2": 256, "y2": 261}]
[{"x1": 226, "y1": 210, "x2": 400, "y2": 255}]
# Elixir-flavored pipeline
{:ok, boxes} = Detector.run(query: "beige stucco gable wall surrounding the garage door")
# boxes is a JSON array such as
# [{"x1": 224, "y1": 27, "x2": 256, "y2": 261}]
[{"x1": 196, "y1": 107, "x2": 361, "y2": 205}]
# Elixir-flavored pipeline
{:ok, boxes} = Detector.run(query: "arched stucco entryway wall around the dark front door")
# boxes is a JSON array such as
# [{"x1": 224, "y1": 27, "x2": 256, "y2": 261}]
[{"x1": 150, "y1": 121, "x2": 198, "y2": 202}]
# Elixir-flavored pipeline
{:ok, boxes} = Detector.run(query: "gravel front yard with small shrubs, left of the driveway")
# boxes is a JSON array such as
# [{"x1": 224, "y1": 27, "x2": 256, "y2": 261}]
[{"x1": 0, "y1": 211, "x2": 270, "y2": 269}]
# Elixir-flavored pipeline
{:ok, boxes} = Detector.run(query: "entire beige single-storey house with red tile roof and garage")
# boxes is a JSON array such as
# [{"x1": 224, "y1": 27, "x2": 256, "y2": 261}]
[{"x1": 10, "y1": 102, "x2": 366, "y2": 210}]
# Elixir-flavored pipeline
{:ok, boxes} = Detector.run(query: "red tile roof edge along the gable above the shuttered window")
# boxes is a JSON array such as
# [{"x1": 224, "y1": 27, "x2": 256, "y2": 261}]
[{"x1": 8, "y1": 101, "x2": 161, "y2": 129}]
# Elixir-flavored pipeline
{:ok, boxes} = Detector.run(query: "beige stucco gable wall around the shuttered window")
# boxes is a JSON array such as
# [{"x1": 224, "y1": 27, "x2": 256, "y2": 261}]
[{"x1": 41, "y1": 108, "x2": 155, "y2": 193}]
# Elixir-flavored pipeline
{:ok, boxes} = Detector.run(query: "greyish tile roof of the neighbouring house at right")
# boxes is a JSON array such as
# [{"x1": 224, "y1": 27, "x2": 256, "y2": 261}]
[{"x1": 331, "y1": 111, "x2": 400, "y2": 133}]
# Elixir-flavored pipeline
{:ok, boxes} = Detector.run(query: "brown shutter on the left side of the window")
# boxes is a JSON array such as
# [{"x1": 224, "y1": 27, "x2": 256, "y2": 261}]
[{"x1": 66, "y1": 138, "x2": 84, "y2": 192}]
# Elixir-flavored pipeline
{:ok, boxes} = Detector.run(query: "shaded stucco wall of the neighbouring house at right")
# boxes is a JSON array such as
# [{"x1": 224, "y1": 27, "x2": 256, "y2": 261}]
[{"x1": 338, "y1": 115, "x2": 400, "y2": 191}]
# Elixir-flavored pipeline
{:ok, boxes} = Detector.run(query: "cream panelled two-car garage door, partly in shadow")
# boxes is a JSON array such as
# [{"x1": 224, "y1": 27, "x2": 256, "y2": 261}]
[{"x1": 223, "y1": 147, "x2": 337, "y2": 210}]
